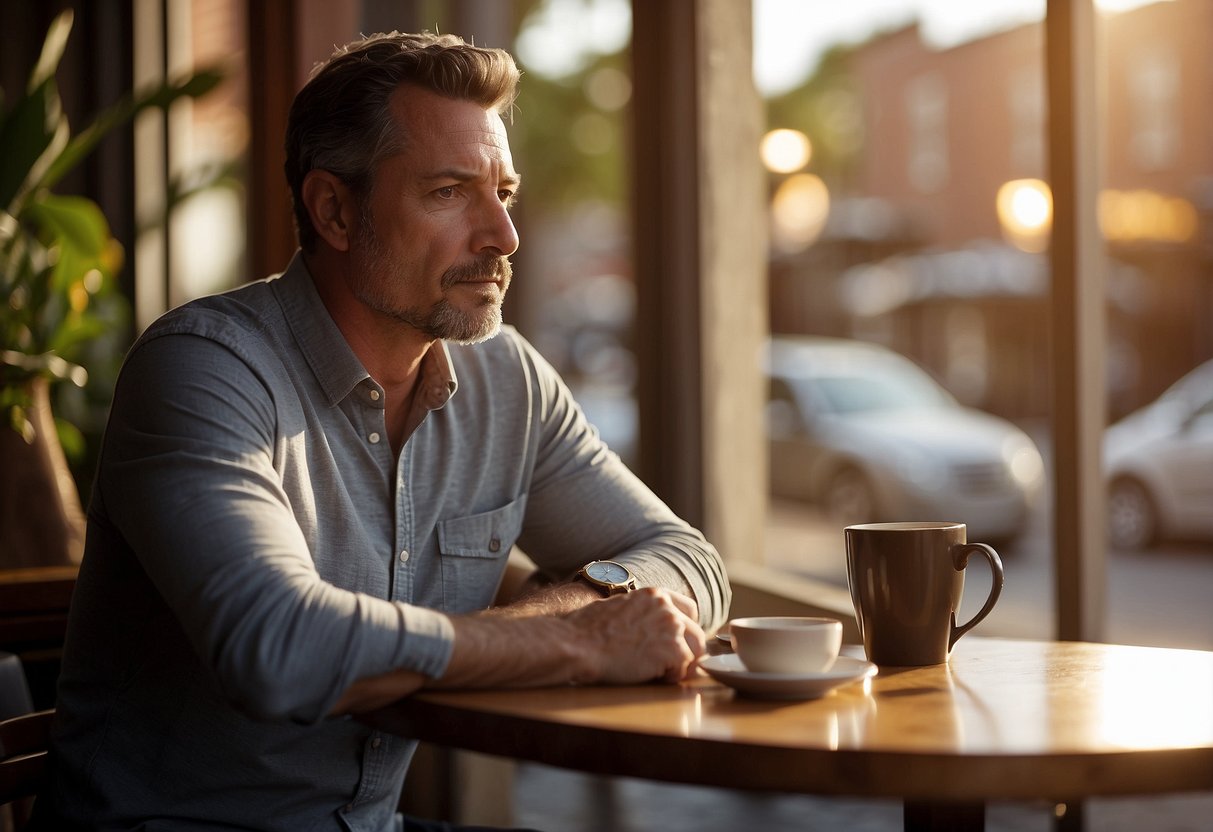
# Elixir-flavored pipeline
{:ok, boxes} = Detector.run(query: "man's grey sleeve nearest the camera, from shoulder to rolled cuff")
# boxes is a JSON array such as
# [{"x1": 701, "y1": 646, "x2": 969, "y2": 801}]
[{"x1": 97, "y1": 335, "x2": 454, "y2": 722}]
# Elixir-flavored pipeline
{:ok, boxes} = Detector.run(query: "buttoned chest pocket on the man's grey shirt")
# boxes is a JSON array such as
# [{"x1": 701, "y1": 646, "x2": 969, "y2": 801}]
[{"x1": 438, "y1": 495, "x2": 526, "y2": 612}]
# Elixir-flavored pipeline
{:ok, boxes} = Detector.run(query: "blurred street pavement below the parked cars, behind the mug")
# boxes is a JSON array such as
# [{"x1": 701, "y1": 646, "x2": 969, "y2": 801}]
[{"x1": 767, "y1": 500, "x2": 1213, "y2": 650}]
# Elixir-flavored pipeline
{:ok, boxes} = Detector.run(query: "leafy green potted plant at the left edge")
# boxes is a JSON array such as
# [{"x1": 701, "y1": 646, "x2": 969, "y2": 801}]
[{"x1": 0, "y1": 10, "x2": 222, "y2": 568}]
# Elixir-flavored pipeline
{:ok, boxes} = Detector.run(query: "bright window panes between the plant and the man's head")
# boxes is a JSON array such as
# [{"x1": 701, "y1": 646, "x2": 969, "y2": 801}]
[{"x1": 132, "y1": 0, "x2": 249, "y2": 330}]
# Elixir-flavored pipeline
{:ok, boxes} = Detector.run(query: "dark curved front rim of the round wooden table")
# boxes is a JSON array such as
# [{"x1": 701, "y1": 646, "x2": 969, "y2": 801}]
[{"x1": 358, "y1": 694, "x2": 1213, "y2": 800}]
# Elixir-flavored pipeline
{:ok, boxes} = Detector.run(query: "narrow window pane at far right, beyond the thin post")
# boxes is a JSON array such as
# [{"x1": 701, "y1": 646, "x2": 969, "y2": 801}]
[{"x1": 1099, "y1": 0, "x2": 1213, "y2": 650}]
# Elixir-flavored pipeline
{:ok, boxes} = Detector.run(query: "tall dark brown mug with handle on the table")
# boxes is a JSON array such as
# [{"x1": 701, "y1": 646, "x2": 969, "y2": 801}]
[{"x1": 843, "y1": 523, "x2": 1003, "y2": 667}]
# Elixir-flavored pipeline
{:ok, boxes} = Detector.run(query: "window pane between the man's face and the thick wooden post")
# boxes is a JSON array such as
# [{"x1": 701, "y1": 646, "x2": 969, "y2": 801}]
[{"x1": 506, "y1": 0, "x2": 637, "y2": 465}]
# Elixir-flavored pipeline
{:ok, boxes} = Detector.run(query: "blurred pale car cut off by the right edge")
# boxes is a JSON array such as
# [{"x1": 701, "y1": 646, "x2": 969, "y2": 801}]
[{"x1": 1104, "y1": 361, "x2": 1213, "y2": 549}]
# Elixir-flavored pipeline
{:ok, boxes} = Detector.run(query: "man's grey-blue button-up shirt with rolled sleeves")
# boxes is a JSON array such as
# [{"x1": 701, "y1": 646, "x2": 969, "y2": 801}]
[{"x1": 40, "y1": 257, "x2": 729, "y2": 832}]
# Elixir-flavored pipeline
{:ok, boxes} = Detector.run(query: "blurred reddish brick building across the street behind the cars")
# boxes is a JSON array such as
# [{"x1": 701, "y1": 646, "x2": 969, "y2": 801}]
[{"x1": 770, "y1": 0, "x2": 1213, "y2": 418}]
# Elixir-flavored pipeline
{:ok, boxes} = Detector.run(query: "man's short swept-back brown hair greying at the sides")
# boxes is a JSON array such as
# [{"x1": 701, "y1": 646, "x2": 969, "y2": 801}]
[{"x1": 285, "y1": 32, "x2": 520, "y2": 251}]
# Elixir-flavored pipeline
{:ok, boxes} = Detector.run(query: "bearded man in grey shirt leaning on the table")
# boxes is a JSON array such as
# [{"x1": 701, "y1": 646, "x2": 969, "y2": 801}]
[{"x1": 39, "y1": 34, "x2": 729, "y2": 832}]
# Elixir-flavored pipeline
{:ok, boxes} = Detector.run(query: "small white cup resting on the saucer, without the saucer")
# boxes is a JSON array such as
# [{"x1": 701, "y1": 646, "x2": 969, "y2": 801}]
[{"x1": 729, "y1": 615, "x2": 842, "y2": 674}]
